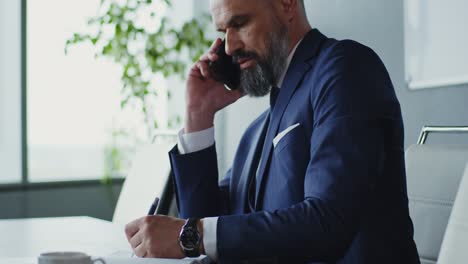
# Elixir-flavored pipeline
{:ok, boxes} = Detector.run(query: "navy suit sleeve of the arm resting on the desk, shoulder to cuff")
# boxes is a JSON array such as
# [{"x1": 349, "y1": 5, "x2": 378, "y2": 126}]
[{"x1": 217, "y1": 43, "x2": 401, "y2": 261}]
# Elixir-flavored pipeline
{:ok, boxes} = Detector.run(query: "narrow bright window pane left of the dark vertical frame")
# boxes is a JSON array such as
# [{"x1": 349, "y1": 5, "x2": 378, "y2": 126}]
[{"x1": 0, "y1": 0, "x2": 21, "y2": 183}]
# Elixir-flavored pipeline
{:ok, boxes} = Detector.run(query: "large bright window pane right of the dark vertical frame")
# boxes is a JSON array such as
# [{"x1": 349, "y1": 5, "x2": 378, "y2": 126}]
[{"x1": 27, "y1": 0, "x2": 172, "y2": 182}]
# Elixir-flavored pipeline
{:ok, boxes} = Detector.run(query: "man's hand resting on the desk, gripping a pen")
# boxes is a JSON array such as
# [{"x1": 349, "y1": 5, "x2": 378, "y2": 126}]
[{"x1": 125, "y1": 215, "x2": 203, "y2": 258}]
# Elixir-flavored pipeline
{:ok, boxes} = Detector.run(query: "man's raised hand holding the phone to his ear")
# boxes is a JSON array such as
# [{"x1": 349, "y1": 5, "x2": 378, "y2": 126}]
[{"x1": 185, "y1": 38, "x2": 243, "y2": 133}]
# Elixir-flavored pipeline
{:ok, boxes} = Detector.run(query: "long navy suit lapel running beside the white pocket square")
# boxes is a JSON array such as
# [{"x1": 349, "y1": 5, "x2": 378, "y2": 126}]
[{"x1": 255, "y1": 29, "x2": 326, "y2": 209}]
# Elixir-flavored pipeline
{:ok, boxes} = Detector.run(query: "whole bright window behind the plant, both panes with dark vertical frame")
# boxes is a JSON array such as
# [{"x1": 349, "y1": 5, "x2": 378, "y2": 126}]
[{"x1": 0, "y1": 0, "x2": 193, "y2": 184}]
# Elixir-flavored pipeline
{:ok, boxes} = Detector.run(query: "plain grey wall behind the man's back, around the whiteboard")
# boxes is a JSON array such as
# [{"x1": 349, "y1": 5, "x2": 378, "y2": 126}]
[{"x1": 306, "y1": 0, "x2": 468, "y2": 147}]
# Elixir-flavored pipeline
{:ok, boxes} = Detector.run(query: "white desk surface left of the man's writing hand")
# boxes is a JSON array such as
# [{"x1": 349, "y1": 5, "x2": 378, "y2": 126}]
[{"x1": 0, "y1": 217, "x2": 131, "y2": 259}]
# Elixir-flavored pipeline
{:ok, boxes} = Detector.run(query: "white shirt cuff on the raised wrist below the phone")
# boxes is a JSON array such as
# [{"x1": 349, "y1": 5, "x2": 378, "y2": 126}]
[{"x1": 177, "y1": 127, "x2": 214, "y2": 155}]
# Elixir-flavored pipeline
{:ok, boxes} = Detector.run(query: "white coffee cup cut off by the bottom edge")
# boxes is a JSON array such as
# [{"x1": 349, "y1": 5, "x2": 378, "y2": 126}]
[{"x1": 37, "y1": 251, "x2": 106, "y2": 264}]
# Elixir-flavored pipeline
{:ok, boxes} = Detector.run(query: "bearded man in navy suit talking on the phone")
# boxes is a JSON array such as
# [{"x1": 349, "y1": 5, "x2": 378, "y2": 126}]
[{"x1": 126, "y1": 0, "x2": 419, "y2": 264}]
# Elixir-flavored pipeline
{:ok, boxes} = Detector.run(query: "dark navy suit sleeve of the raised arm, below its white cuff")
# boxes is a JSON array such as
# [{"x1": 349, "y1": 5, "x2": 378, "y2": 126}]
[{"x1": 169, "y1": 145, "x2": 230, "y2": 219}]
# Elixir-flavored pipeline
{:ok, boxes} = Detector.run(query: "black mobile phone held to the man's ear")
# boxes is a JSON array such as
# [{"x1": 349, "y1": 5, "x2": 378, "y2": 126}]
[{"x1": 209, "y1": 40, "x2": 240, "y2": 90}]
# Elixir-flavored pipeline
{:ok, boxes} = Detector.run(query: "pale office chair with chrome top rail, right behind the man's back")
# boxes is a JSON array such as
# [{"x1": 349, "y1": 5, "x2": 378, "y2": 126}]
[{"x1": 405, "y1": 127, "x2": 468, "y2": 264}]
